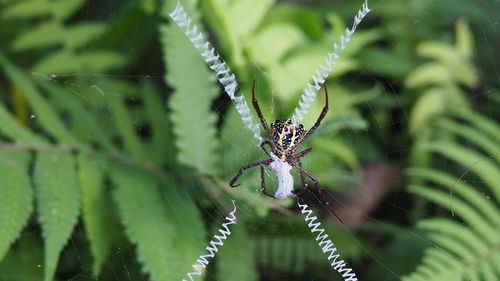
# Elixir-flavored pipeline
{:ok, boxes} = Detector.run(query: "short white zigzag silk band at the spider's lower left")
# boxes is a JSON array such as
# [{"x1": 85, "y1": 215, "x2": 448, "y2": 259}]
[{"x1": 182, "y1": 201, "x2": 236, "y2": 281}]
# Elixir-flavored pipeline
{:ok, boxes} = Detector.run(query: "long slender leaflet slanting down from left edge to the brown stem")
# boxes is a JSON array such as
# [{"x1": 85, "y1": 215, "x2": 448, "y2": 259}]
[{"x1": 0, "y1": 53, "x2": 78, "y2": 145}]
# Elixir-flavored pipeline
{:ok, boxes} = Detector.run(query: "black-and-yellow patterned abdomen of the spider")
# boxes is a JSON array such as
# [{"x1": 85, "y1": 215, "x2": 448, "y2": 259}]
[{"x1": 271, "y1": 119, "x2": 306, "y2": 158}]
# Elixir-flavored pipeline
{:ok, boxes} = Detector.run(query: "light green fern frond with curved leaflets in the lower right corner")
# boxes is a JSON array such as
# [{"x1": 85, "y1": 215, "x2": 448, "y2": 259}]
[{"x1": 403, "y1": 111, "x2": 500, "y2": 280}]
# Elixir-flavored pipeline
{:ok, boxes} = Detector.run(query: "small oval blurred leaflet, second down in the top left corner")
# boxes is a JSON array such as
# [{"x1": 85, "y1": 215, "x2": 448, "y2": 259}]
[{"x1": 13, "y1": 22, "x2": 64, "y2": 51}]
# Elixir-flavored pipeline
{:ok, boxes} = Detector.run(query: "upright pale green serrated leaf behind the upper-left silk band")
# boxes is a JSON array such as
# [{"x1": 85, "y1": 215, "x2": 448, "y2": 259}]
[{"x1": 160, "y1": 23, "x2": 218, "y2": 174}]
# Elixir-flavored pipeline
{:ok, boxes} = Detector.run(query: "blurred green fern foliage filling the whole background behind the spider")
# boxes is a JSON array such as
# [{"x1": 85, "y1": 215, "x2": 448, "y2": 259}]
[{"x1": 0, "y1": 0, "x2": 500, "y2": 281}]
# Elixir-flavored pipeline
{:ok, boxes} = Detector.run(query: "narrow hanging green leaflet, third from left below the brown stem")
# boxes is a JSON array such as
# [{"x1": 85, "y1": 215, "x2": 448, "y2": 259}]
[{"x1": 78, "y1": 154, "x2": 113, "y2": 277}]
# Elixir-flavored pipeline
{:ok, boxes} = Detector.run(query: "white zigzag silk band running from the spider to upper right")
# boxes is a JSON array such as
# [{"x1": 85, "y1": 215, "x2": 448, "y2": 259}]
[{"x1": 292, "y1": 0, "x2": 370, "y2": 124}]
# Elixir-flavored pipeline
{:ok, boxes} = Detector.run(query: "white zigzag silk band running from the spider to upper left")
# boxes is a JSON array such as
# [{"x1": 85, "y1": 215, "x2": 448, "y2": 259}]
[{"x1": 169, "y1": 2, "x2": 263, "y2": 145}]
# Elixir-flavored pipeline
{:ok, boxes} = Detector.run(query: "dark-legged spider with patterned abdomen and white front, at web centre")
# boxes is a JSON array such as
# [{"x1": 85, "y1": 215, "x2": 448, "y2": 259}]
[{"x1": 229, "y1": 81, "x2": 342, "y2": 223}]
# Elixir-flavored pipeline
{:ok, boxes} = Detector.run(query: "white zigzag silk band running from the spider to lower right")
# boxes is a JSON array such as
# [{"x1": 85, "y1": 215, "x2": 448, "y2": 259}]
[{"x1": 297, "y1": 198, "x2": 358, "y2": 281}]
